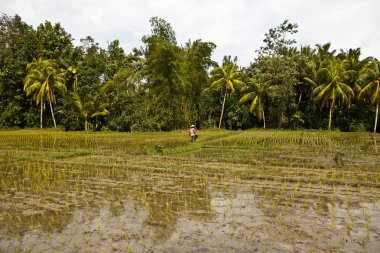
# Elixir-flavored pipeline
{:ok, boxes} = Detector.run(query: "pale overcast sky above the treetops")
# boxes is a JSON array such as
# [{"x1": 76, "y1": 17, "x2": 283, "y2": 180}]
[{"x1": 0, "y1": 0, "x2": 380, "y2": 66}]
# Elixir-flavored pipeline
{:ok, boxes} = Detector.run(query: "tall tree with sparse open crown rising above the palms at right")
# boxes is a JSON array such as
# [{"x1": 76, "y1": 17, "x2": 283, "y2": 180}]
[{"x1": 255, "y1": 20, "x2": 298, "y2": 128}]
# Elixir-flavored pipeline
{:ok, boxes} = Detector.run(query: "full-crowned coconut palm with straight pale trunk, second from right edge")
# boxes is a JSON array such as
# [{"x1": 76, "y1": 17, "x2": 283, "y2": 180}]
[{"x1": 305, "y1": 60, "x2": 354, "y2": 130}]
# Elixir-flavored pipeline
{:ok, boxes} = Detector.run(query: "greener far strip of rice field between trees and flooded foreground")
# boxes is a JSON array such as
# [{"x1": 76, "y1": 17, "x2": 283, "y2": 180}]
[{"x1": 0, "y1": 130, "x2": 380, "y2": 182}]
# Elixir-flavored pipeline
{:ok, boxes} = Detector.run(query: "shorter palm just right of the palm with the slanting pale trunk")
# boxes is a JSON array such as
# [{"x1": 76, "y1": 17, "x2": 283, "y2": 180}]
[{"x1": 239, "y1": 78, "x2": 267, "y2": 129}]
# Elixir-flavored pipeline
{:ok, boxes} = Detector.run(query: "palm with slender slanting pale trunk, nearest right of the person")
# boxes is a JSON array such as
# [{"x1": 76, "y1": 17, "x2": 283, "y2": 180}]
[{"x1": 210, "y1": 57, "x2": 244, "y2": 129}]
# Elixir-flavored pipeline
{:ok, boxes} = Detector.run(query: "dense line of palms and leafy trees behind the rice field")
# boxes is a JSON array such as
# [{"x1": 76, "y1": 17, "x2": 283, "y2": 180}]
[{"x1": 0, "y1": 14, "x2": 380, "y2": 132}]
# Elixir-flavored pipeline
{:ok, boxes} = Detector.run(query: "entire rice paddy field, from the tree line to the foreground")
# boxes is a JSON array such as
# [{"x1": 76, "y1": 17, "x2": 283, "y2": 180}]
[{"x1": 0, "y1": 130, "x2": 380, "y2": 252}]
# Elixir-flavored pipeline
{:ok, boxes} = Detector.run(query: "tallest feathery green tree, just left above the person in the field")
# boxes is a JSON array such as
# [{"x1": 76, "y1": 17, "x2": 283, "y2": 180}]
[{"x1": 142, "y1": 17, "x2": 184, "y2": 130}]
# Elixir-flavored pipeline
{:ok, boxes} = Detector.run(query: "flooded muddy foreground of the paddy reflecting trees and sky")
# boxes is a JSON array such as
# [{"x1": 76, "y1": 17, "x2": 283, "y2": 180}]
[{"x1": 0, "y1": 165, "x2": 380, "y2": 252}]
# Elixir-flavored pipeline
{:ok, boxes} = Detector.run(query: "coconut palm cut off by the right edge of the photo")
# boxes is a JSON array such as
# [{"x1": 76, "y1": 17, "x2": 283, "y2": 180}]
[{"x1": 358, "y1": 60, "x2": 380, "y2": 133}]
